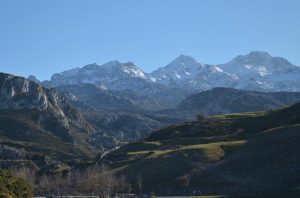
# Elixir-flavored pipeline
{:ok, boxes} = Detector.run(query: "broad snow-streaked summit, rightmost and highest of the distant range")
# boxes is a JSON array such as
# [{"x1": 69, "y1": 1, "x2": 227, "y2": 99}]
[{"x1": 220, "y1": 51, "x2": 300, "y2": 91}]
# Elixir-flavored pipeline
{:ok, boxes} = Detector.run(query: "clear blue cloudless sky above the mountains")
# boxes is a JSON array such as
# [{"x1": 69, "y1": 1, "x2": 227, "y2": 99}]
[{"x1": 0, "y1": 0, "x2": 300, "y2": 80}]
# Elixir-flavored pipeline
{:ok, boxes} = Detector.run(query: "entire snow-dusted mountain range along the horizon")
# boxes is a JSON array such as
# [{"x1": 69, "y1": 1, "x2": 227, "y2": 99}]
[{"x1": 38, "y1": 51, "x2": 300, "y2": 108}]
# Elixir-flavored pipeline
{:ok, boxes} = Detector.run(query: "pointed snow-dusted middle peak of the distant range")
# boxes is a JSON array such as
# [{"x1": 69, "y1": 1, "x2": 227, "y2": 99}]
[{"x1": 149, "y1": 55, "x2": 236, "y2": 92}]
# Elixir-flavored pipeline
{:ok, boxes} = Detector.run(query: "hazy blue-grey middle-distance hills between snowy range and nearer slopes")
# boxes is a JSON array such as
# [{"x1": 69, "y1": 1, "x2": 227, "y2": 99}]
[{"x1": 56, "y1": 84, "x2": 300, "y2": 142}]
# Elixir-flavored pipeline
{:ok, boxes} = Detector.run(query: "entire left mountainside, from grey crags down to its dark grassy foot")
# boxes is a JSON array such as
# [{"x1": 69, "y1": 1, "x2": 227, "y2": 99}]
[{"x1": 0, "y1": 73, "x2": 112, "y2": 170}]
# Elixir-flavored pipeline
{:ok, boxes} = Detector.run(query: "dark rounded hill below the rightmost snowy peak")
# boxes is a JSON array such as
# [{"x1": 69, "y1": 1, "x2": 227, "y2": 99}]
[{"x1": 177, "y1": 87, "x2": 300, "y2": 115}]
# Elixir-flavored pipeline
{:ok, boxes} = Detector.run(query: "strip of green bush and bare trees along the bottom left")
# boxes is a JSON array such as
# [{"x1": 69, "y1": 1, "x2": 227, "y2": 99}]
[{"x1": 0, "y1": 166, "x2": 131, "y2": 197}]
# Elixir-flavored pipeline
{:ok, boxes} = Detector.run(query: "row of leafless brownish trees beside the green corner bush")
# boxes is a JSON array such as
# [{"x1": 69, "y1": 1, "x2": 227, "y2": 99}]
[{"x1": 12, "y1": 166, "x2": 131, "y2": 195}]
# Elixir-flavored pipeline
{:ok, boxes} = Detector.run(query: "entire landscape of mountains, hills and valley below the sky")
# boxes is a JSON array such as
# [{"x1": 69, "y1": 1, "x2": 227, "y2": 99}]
[{"x1": 0, "y1": 51, "x2": 300, "y2": 196}]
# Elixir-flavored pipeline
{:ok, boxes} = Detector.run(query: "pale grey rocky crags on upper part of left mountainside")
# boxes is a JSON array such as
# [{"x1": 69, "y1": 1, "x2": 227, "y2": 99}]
[{"x1": 0, "y1": 73, "x2": 113, "y2": 148}]
